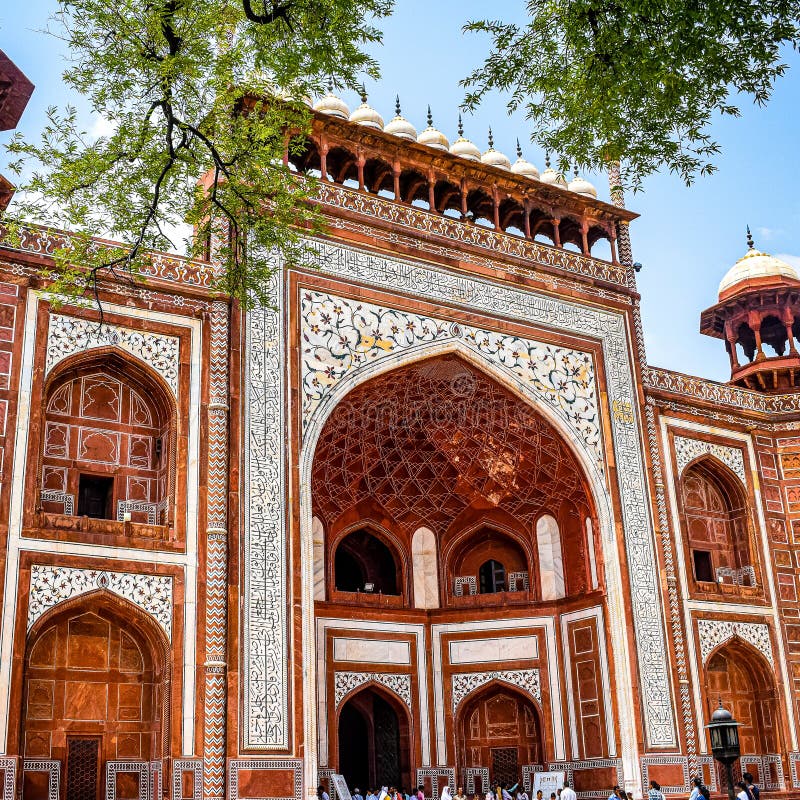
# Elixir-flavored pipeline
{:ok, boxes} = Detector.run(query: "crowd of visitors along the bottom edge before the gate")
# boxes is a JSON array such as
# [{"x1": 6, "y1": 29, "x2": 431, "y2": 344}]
[{"x1": 317, "y1": 772, "x2": 761, "y2": 800}]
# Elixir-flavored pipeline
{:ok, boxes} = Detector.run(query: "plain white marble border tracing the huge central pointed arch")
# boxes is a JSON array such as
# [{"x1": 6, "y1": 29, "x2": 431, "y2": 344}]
[{"x1": 300, "y1": 340, "x2": 638, "y2": 774}]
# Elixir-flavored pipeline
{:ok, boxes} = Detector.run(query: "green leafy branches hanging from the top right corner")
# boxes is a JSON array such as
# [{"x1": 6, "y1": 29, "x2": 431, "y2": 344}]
[{"x1": 464, "y1": 0, "x2": 800, "y2": 189}]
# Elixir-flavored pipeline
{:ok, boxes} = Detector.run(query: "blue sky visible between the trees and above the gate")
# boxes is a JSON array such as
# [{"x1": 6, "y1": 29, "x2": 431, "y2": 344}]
[{"x1": 0, "y1": 0, "x2": 800, "y2": 380}]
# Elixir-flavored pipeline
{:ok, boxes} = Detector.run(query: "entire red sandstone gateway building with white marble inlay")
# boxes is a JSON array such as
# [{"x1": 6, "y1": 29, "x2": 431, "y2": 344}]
[{"x1": 0, "y1": 56, "x2": 800, "y2": 800}]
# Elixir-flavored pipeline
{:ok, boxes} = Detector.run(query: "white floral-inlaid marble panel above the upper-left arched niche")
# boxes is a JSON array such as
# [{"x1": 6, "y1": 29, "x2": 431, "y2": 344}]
[{"x1": 45, "y1": 314, "x2": 180, "y2": 397}]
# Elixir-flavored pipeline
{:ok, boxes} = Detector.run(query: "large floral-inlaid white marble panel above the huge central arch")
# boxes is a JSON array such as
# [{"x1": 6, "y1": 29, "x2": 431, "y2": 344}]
[{"x1": 300, "y1": 290, "x2": 603, "y2": 470}]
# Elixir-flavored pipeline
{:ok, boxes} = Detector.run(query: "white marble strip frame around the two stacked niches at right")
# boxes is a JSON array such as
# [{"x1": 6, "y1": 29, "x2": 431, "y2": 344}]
[{"x1": 659, "y1": 415, "x2": 798, "y2": 755}]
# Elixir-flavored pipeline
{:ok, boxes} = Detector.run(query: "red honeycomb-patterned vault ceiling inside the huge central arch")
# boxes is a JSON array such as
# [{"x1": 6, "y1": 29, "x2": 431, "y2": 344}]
[{"x1": 311, "y1": 355, "x2": 590, "y2": 535}]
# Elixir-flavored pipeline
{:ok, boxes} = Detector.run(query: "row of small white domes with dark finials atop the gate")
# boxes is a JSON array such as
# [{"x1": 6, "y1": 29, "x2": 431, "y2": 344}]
[{"x1": 314, "y1": 90, "x2": 597, "y2": 198}]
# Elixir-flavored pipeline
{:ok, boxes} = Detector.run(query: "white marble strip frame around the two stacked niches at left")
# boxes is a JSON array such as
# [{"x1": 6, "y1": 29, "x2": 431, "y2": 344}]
[{"x1": 0, "y1": 289, "x2": 202, "y2": 755}]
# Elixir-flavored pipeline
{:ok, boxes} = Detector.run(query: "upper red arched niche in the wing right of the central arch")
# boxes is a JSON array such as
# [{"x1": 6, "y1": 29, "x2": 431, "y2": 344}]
[{"x1": 679, "y1": 456, "x2": 759, "y2": 590}]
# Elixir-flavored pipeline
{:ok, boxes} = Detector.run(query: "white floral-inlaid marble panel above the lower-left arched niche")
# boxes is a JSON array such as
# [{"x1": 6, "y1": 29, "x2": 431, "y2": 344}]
[{"x1": 28, "y1": 564, "x2": 172, "y2": 640}]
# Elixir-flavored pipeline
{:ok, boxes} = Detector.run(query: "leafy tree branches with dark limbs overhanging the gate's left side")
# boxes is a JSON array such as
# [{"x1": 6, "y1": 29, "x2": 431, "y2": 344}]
[{"x1": 10, "y1": 0, "x2": 392, "y2": 304}]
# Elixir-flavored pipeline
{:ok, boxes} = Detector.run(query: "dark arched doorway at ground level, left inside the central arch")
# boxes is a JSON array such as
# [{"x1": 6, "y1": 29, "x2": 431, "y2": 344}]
[{"x1": 338, "y1": 688, "x2": 411, "y2": 794}]
